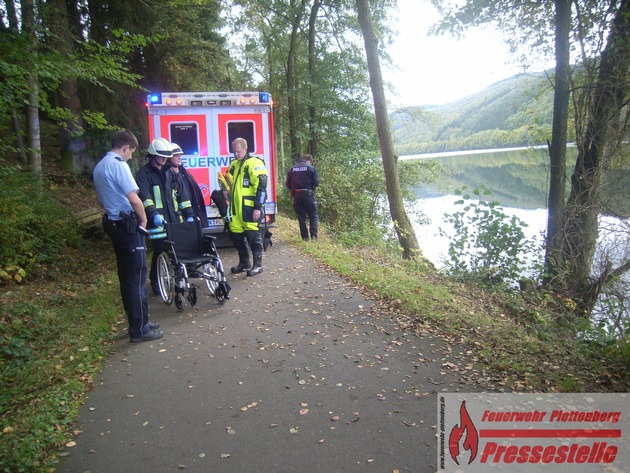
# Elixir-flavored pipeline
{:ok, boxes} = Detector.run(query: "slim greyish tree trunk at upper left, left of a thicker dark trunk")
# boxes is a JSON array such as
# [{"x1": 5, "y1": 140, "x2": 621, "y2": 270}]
[{"x1": 21, "y1": 0, "x2": 42, "y2": 174}]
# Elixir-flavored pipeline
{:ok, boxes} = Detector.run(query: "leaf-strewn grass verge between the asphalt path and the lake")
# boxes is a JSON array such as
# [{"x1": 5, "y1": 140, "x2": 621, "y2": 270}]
[{"x1": 276, "y1": 217, "x2": 630, "y2": 392}]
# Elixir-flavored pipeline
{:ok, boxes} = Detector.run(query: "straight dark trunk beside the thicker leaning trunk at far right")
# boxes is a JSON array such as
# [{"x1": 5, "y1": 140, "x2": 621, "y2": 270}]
[{"x1": 545, "y1": 0, "x2": 571, "y2": 280}]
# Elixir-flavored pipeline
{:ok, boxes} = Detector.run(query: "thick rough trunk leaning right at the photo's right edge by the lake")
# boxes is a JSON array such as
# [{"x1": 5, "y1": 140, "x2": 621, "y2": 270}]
[{"x1": 561, "y1": 0, "x2": 630, "y2": 316}]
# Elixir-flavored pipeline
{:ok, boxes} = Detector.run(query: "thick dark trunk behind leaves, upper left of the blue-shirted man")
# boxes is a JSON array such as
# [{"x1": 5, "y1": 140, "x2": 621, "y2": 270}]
[{"x1": 50, "y1": 0, "x2": 89, "y2": 174}]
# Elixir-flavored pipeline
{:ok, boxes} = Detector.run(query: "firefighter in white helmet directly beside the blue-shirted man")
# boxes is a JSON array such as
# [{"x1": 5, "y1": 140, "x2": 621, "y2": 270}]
[{"x1": 136, "y1": 138, "x2": 194, "y2": 295}]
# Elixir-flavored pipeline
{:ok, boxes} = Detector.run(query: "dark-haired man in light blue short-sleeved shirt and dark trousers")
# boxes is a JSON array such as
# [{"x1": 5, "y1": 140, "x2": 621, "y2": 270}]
[{"x1": 93, "y1": 130, "x2": 164, "y2": 342}]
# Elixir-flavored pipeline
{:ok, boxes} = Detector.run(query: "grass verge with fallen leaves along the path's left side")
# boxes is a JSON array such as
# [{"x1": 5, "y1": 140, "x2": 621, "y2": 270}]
[{"x1": 0, "y1": 240, "x2": 120, "y2": 473}]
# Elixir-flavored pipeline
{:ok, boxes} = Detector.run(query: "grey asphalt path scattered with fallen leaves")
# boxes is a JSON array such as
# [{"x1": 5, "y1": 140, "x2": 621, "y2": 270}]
[{"x1": 57, "y1": 240, "x2": 480, "y2": 473}]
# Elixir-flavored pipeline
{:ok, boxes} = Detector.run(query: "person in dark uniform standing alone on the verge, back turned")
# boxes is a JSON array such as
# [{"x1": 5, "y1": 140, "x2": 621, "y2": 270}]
[{"x1": 284, "y1": 154, "x2": 319, "y2": 241}]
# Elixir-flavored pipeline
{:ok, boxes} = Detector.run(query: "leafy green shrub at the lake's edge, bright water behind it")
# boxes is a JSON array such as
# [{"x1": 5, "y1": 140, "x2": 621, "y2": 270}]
[{"x1": 440, "y1": 188, "x2": 533, "y2": 286}]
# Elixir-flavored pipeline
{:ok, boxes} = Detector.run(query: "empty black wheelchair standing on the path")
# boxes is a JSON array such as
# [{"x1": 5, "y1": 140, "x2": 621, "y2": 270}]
[{"x1": 157, "y1": 219, "x2": 231, "y2": 311}]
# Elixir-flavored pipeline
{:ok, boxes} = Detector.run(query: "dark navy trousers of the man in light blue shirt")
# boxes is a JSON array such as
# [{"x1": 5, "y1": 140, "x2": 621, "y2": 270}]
[{"x1": 103, "y1": 221, "x2": 149, "y2": 338}]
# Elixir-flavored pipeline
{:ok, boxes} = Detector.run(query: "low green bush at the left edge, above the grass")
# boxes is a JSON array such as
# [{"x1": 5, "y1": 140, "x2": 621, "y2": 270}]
[{"x1": 0, "y1": 167, "x2": 79, "y2": 285}]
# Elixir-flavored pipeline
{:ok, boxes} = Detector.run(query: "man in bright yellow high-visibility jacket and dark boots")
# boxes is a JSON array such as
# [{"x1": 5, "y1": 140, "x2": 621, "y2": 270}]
[{"x1": 228, "y1": 138, "x2": 268, "y2": 276}]
